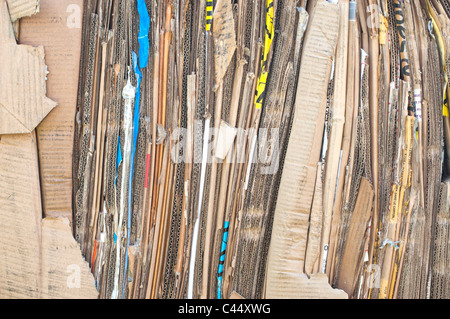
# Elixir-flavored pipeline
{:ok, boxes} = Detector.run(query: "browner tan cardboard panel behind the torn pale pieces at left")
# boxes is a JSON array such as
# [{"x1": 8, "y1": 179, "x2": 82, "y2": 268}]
[{"x1": 20, "y1": 0, "x2": 83, "y2": 220}]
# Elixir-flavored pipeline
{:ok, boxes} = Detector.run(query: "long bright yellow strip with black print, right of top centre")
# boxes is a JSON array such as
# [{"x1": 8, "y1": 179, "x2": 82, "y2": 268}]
[{"x1": 255, "y1": 0, "x2": 273, "y2": 109}]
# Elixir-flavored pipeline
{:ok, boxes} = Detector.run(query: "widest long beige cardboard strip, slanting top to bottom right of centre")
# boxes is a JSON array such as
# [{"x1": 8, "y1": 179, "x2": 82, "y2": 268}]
[{"x1": 266, "y1": 1, "x2": 339, "y2": 298}]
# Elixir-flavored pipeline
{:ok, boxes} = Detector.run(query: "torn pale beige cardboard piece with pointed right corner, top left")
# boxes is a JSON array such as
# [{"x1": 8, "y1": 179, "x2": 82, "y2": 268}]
[{"x1": 0, "y1": 0, "x2": 56, "y2": 135}]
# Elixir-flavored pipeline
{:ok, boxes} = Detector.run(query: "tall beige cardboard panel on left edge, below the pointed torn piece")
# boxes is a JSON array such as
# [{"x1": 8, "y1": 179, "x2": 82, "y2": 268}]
[{"x1": 0, "y1": 134, "x2": 42, "y2": 299}]
